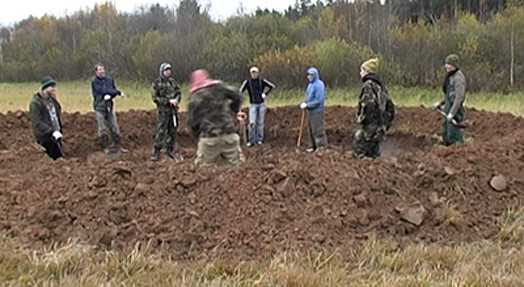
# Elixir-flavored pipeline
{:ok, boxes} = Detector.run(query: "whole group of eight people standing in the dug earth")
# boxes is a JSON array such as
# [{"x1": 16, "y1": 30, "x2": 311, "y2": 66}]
[{"x1": 29, "y1": 54, "x2": 466, "y2": 167}]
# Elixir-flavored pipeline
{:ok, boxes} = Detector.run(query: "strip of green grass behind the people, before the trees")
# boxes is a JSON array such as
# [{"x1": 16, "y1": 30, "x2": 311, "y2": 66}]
[{"x1": 4, "y1": 80, "x2": 524, "y2": 116}]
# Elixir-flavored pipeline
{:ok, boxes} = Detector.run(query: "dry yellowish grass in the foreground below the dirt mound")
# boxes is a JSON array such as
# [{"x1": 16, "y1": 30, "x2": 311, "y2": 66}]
[{"x1": 0, "y1": 235, "x2": 524, "y2": 287}]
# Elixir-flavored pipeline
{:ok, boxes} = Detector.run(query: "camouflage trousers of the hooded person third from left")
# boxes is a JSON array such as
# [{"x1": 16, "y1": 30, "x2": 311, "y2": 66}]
[{"x1": 155, "y1": 109, "x2": 178, "y2": 149}]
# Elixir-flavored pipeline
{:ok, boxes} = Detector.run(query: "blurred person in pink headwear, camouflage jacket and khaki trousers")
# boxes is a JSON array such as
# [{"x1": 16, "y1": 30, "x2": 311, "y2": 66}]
[{"x1": 187, "y1": 70, "x2": 246, "y2": 167}]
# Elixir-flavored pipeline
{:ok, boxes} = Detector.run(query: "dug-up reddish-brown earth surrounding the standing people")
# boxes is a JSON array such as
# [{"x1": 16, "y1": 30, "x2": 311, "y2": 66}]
[{"x1": 0, "y1": 107, "x2": 524, "y2": 260}]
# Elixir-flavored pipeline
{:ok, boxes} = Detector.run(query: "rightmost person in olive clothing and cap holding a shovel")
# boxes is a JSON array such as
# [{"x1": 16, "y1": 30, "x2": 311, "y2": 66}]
[{"x1": 433, "y1": 54, "x2": 466, "y2": 146}]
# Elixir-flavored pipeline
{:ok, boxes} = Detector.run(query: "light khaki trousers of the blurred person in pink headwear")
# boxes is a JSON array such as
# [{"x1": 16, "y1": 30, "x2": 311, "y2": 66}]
[{"x1": 195, "y1": 133, "x2": 245, "y2": 167}]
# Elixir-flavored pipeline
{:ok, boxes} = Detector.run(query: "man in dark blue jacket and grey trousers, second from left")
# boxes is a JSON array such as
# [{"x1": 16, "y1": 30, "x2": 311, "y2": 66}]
[{"x1": 91, "y1": 64, "x2": 128, "y2": 154}]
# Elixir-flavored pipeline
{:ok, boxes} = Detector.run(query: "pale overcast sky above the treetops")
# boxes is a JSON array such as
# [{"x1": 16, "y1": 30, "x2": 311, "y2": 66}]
[{"x1": 0, "y1": 0, "x2": 296, "y2": 25}]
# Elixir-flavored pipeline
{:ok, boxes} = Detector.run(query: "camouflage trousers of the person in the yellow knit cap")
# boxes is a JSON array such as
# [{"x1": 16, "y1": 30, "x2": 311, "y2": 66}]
[{"x1": 352, "y1": 125, "x2": 383, "y2": 158}]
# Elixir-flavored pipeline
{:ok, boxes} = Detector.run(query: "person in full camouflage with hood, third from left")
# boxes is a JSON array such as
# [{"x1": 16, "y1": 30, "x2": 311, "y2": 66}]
[{"x1": 151, "y1": 63, "x2": 182, "y2": 161}]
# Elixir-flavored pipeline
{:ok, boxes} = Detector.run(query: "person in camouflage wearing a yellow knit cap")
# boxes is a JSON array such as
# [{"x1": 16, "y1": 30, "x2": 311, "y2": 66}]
[{"x1": 353, "y1": 58, "x2": 395, "y2": 158}]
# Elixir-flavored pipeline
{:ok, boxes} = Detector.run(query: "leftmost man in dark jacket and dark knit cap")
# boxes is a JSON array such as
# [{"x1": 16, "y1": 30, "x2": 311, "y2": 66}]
[{"x1": 29, "y1": 76, "x2": 64, "y2": 160}]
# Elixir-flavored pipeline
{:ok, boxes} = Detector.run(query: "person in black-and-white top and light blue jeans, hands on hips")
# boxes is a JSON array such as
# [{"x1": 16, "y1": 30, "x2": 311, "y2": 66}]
[{"x1": 240, "y1": 67, "x2": 275, "y2": 147}]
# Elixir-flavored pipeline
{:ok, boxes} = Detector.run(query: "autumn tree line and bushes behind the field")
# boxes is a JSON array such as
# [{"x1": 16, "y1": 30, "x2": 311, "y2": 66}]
[{"x1": 0, "y1": 0, "x2": 524, "y2": 91}]
